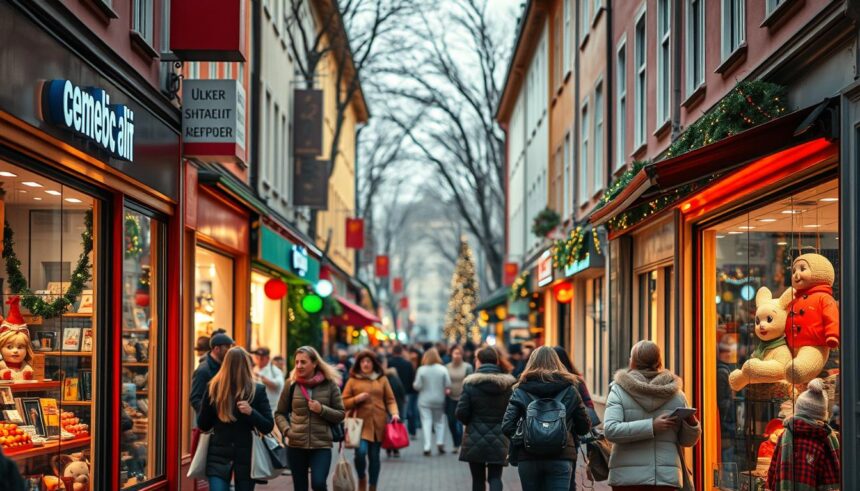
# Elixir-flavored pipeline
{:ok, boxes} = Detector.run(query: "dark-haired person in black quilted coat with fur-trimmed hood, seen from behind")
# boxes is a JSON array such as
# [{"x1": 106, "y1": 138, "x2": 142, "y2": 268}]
[{"x1": 456, "y1": 346, "x2": 516, "y2": 491}]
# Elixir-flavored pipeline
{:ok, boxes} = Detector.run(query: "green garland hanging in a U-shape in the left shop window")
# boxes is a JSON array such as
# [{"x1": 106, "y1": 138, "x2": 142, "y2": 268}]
[{"x1": 3, "y1": 210, "x2": 93, "y2": 319}]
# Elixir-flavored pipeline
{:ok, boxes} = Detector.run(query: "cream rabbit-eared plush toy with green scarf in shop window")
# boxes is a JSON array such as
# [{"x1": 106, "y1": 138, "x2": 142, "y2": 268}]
[{"x1": 729, "y1": 287, "x2": 793, "y2": 391}]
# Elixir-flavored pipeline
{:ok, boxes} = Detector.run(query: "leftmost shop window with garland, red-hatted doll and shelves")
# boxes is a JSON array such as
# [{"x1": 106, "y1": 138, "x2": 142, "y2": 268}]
[{"x1": 0, "y1": 160, "x2": 97, "y2": 489}]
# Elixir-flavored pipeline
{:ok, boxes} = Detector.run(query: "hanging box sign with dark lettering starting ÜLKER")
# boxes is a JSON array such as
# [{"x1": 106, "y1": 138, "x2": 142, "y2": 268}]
[{"x1": 182, "y1": 80, "x2": 245, "y2": 162}]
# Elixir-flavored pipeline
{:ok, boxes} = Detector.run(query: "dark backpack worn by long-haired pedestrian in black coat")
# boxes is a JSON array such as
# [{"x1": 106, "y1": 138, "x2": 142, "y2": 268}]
[{"x1": 523, "y1": 390, "x2": 569, "y2": 457}]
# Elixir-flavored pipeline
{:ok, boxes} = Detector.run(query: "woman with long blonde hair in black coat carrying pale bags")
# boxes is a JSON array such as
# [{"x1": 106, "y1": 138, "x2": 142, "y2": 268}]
[{"x1": 197, "y1": 347, "x2": 275, "y2": 491}]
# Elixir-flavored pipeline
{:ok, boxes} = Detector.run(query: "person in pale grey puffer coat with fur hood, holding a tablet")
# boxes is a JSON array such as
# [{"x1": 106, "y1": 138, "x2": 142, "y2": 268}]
[{"x1": 603, "y1": 340, "x2": 702, "y2": 491}]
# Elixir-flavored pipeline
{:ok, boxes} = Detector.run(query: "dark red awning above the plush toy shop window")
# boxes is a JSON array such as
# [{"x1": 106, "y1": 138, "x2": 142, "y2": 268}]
[{"x1": 591, "y1": 100, "x2": 830, "y2": 225}]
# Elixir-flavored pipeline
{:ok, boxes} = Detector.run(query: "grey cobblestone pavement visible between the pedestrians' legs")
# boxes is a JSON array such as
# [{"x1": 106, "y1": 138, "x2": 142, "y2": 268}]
[{"x1": 256, "y1": 430, "x2": 609, "y2": 491}]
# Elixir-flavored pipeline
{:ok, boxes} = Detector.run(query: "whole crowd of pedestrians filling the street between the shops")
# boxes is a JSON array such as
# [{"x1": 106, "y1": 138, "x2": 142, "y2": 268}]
[{"x1": 181, "y1": 333, "x2": 701, "y2": 491}]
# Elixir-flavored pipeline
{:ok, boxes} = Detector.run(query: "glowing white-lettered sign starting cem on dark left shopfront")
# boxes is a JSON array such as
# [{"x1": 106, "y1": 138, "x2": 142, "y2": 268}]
[{"x1": 43, "y1": 80, "x2": 134, "y2": 162}]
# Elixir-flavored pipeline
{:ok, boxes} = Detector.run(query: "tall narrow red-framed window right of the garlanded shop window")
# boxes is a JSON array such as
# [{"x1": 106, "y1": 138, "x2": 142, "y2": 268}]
[{"x1": 120, "y1": 205, "x2": 165, "y2": 488}]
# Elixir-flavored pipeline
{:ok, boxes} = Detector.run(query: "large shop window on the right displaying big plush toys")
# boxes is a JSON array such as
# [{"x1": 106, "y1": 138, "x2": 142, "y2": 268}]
[{"x1": 702, "y1": 181, "x2": 843, "y2": 490}]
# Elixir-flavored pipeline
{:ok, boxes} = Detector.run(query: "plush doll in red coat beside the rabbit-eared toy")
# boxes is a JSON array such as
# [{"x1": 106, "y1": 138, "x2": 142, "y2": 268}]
[{"x1": 785, "y1": 254, "x2": 839, "y2": 384}]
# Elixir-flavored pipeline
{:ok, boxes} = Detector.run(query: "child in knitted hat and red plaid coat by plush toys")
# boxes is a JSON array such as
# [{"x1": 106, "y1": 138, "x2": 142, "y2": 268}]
[{"x1": 767, "y1": 378, "x2": 842, "y2": 491}]
